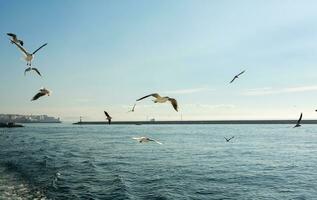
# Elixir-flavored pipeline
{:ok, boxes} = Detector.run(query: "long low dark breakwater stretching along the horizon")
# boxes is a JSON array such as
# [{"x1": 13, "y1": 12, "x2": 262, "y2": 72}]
[{"x1": 73, "y1": 120, "x2": 317, "y2": 125}]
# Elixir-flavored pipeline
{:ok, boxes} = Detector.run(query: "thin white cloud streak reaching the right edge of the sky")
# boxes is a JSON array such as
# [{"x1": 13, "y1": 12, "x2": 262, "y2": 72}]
[{"x1": 243, "y1": 85, "x2": 317, "y2": 96}]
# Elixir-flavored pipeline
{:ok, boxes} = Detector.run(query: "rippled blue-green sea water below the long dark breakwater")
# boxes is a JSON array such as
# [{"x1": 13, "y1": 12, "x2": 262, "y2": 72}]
[{"x1": 0, "y1": 124, "x2": 317, "y2": 200}]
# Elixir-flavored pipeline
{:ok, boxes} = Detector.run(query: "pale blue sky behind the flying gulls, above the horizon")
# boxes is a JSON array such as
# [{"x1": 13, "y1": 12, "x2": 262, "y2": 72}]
[{"x1": 0, "y1": 0, "x2": 317, "y2": 121}]
